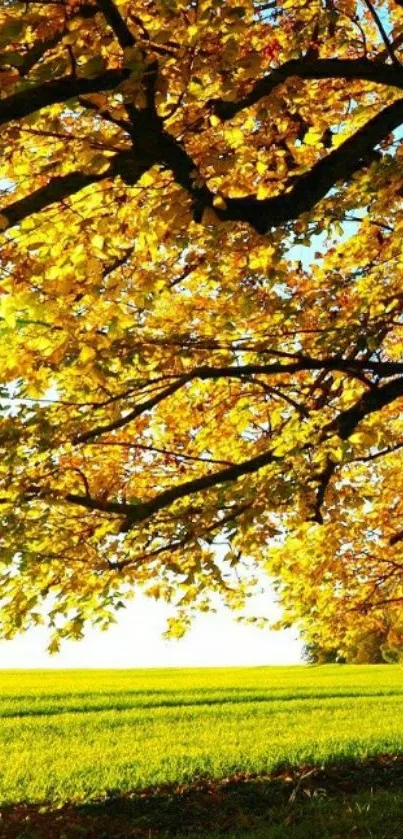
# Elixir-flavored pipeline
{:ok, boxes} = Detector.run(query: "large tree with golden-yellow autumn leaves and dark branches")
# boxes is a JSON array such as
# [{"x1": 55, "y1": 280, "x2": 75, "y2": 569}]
[{"x1": 0, "y1": 0, "x2": 403, "y2": 649}]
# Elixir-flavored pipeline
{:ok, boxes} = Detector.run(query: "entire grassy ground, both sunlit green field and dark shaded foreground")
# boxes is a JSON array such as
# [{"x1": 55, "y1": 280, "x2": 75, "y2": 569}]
[{"x1": 0, "y1": 665, "x2": 403, "y2": 839}]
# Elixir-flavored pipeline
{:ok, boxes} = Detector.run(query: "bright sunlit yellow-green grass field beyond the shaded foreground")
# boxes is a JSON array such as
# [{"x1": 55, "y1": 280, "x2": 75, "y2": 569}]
[{"x1": 0, "y1": 665, "x2": 403, "y2": 839}]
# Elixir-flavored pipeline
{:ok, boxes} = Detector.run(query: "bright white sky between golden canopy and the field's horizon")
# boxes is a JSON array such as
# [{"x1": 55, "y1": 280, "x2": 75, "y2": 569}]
[{"x1": 0, "y1": 594, "x2": 302, "y2": 668}]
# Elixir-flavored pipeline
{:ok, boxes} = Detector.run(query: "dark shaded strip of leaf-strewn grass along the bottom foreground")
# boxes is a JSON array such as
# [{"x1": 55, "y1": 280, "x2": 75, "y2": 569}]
[{"x1": 0, "y1": 755, "x2": 403, "y2": 839}]
